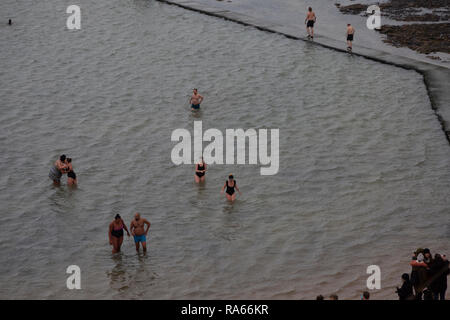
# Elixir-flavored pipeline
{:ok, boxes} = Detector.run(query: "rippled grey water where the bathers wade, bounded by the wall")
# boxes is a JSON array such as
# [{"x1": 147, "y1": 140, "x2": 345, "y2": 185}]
[{"x1": 0, "y1": 0, "x2": 450, "y2": 299}]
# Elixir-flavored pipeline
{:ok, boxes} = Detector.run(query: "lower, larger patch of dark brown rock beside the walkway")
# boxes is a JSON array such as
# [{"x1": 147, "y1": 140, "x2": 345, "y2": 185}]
[{"x1": 379, "y1": 23, "x2": 450, "y2": 54}]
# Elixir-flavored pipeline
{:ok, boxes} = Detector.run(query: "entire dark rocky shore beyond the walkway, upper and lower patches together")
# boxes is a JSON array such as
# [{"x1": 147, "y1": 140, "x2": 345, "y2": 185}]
[{"x1": 336, "y1": 0, "x2": 450, "y2": 59}]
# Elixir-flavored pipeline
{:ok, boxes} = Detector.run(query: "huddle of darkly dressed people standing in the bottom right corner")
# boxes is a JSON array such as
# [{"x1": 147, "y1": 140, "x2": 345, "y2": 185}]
[{"x1": 396, "y1": 248, "x2": 450, "y2": 300}]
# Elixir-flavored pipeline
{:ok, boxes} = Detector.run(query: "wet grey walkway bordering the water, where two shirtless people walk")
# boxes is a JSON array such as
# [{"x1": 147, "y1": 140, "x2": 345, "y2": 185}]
[{"x1": 157, "y1": 0, "x2": 450, "y2": 143}]
